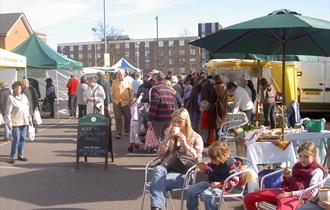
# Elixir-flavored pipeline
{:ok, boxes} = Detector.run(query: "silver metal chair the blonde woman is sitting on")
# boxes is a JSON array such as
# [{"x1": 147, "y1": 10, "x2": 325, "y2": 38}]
[{"x1": 141, "y1": 157, "x2": 197, "y2": 210}]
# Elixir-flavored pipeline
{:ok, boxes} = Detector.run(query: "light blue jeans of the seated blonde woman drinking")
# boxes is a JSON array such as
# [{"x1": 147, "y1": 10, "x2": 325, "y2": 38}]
[{"x1": 149, "y1": 165, "x2": 185, "y2": 209}]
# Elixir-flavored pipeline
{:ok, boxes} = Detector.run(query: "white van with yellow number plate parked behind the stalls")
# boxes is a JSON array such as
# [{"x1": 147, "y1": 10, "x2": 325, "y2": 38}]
[{"x1": 297, "y1": 57, "x2": 330, "y2": 112}]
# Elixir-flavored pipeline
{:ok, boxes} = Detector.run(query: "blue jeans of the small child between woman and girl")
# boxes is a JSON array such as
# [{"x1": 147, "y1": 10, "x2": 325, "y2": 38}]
[{"x1": 187, "y1": 181, "x2": 221, "y2": 210}]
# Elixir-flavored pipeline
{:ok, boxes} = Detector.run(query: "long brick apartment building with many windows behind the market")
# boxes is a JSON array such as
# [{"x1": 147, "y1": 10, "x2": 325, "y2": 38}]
[{"x1": 57, "y1": 35, "x2": 205, "y2": 73}]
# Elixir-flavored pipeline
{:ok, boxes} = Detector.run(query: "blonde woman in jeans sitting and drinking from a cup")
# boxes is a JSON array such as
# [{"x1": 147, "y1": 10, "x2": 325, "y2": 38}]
[{"x1": 149, "y1": 108, "x2": 203, "y2": 210}]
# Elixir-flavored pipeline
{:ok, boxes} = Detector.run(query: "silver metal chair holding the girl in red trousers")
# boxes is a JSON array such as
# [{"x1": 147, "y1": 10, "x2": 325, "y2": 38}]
[{"x1": 258, "y1": 169, "x2": 328, "y2": 210}]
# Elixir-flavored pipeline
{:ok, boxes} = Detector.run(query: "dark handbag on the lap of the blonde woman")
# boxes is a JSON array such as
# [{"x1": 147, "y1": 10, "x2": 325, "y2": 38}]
[{"x1": 166, "y1": 137, "x2": 197, "y2": 174}]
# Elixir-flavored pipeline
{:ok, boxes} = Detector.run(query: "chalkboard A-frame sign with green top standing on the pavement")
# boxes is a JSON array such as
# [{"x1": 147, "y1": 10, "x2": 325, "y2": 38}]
[{"x1": 76, "y1": 114, "x2": 111, "y2": 170}]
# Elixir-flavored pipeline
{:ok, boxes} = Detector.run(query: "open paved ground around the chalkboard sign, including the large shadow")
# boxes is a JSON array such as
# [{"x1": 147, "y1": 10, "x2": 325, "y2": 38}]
[{"x1": 0, "y1": 119, "x2": 242, "y2": 210}]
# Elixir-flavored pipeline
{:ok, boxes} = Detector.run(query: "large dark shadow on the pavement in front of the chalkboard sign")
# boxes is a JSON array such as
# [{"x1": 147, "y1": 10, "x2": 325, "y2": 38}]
[{"x1": 0, "y1": 163, "x2": 144, "y2": 206}]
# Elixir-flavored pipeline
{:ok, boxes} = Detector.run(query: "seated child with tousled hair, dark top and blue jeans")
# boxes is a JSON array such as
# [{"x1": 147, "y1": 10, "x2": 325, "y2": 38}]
[{"x1": 187, "y1": 141, "x2": 241, "y2": 210}]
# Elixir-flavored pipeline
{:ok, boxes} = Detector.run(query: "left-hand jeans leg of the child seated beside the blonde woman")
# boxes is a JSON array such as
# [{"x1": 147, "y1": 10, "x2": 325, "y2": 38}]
[{"x1": 187, "y1": 181, "x2": 210, "y2": 210}]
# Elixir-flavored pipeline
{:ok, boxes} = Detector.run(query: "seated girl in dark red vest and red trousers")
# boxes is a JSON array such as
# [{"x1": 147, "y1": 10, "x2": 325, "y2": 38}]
[{"x1": 244, "y1": 142, "x2": 323, "y2": 210}]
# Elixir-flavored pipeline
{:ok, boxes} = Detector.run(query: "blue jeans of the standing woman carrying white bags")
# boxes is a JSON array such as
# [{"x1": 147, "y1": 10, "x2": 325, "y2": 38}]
[{"x1": 10, "y1": 125, "x2": 28, "y2": 159}]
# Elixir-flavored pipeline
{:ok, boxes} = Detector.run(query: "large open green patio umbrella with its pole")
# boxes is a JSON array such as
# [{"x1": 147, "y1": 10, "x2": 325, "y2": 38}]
[{"x1": 190, "y1": 9, "x2": 330, "y2": 133}]
